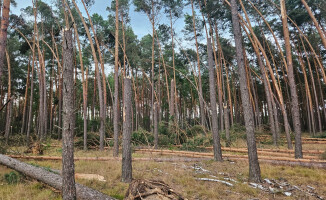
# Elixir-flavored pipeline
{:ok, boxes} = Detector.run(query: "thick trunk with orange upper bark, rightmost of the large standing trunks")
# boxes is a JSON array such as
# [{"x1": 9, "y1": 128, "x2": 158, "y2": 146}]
[{"x1": 280, "y1": 0, "x2": 303, "y2": 158}]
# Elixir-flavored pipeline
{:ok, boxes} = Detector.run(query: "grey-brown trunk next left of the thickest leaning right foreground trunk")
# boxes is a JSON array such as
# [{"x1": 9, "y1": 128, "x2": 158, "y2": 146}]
[{"x1": 207, "y1": 38, "x2": 223, "y2": 161}]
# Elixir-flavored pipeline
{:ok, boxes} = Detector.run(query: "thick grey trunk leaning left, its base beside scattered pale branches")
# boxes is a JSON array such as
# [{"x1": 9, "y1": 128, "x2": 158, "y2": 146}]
[{"x1": 231, "y1": 0, "x2": 261, "y2": 182}]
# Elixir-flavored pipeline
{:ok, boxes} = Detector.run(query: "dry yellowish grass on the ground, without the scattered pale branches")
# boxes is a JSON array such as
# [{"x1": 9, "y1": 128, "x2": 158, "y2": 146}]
[{"x1": 0, "y1": 140, "x2": 326, "y2": 200}]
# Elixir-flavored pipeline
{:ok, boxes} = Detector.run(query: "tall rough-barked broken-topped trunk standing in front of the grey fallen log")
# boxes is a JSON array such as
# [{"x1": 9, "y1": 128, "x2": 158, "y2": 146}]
[{"x1": 62, "y1": 30, "x2": 76, "y2": 200}]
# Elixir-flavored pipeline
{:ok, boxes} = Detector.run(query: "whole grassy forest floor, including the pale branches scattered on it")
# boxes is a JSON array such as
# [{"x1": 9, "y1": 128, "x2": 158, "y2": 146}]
[{"x1": 0, "y1": 135, "x2": 326, "y2": 200}]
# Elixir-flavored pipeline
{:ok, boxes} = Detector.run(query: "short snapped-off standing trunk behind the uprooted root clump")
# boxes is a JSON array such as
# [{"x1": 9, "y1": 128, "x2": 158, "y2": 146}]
[{"x1": 121, "y1": 77, "x2": 132, "y2": 183}]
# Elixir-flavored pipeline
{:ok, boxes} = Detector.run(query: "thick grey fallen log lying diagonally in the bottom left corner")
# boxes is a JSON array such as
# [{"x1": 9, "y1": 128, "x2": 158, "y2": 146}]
[{"x1": 0, "y1": 154, "x2": 115, "y2": 200}]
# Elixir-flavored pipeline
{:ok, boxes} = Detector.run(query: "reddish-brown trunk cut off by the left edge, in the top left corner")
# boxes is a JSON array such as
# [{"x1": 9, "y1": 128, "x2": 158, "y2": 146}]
[{"x1": 0, "y1": 0, "x2": 10, "y2": 90}]
